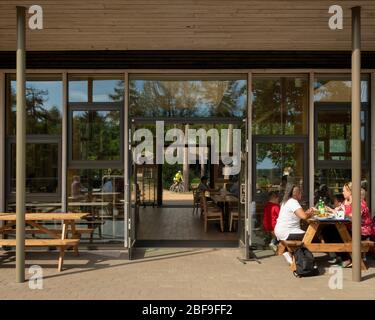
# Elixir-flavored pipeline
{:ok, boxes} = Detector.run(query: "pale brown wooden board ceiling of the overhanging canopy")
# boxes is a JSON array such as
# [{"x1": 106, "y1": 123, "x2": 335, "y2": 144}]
[{"x1": 0, "y1": 0, "x2": 375, "y2": 51}]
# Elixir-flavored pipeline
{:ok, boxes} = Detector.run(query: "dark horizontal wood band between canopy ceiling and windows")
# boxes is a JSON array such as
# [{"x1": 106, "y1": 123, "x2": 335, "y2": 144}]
[{"x1": 0, "y1": 50, "x2": 375, "y2": 69}]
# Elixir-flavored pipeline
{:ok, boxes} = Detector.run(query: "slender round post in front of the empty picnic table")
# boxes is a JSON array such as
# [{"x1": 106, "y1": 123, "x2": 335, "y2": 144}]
[{"x1": 16, "y1": 7, "x2": 26, "y2": 283}]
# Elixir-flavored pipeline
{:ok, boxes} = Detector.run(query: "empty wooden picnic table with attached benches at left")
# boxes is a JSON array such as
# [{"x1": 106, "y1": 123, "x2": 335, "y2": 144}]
[{"x1": 0, "y1": 212, "x2": 88, "y2": 271}]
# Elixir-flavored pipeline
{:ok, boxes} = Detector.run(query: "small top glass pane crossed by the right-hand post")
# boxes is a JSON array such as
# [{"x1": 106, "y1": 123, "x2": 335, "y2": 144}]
[{"x1": 314, "y1": 75, "x2": 369, "y2": 103}]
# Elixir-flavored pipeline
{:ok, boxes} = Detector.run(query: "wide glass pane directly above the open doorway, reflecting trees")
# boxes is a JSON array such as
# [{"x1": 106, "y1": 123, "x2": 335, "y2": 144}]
[{"x1": 129, "y1": 79, "x2": 247, "y2": 117}]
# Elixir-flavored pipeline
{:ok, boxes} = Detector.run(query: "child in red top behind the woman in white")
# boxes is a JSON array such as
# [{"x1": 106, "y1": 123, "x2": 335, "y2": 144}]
[{"x1": 263, "y1": 191, "x2": 280, "y2": 251}]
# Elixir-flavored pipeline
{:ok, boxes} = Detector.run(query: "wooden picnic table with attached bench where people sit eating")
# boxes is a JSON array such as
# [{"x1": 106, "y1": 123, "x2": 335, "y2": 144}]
[{"x1": 278, "y1": 218, "x2": 373, "y2": 270}]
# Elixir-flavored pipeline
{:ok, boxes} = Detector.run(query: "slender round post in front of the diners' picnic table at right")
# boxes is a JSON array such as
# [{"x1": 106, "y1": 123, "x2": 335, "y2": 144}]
[{"x1": 352, "y1": 7, "x2": 361, "y2": 282}]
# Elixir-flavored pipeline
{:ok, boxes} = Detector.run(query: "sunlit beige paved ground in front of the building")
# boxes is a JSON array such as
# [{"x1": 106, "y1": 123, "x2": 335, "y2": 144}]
[{"x1": 0, "y1": 249, "x2": 375, "y2": 300}]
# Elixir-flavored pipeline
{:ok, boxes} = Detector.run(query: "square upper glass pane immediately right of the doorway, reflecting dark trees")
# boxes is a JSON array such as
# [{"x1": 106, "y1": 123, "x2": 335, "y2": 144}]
[{"x1": 253, "y1": 76, "x2": 309, "y2": 135}]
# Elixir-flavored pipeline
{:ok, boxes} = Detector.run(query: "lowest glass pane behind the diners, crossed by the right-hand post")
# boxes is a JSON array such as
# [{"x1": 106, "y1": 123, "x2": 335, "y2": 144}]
[{"x1": 314, "y1": 168, "x2": 370, "y2": 206}]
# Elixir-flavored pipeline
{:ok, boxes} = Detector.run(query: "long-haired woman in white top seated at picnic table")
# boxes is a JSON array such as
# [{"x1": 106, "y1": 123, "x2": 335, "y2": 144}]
[{"x1": 275, "y1": 185, "x2": 313, "y2": 240}]
